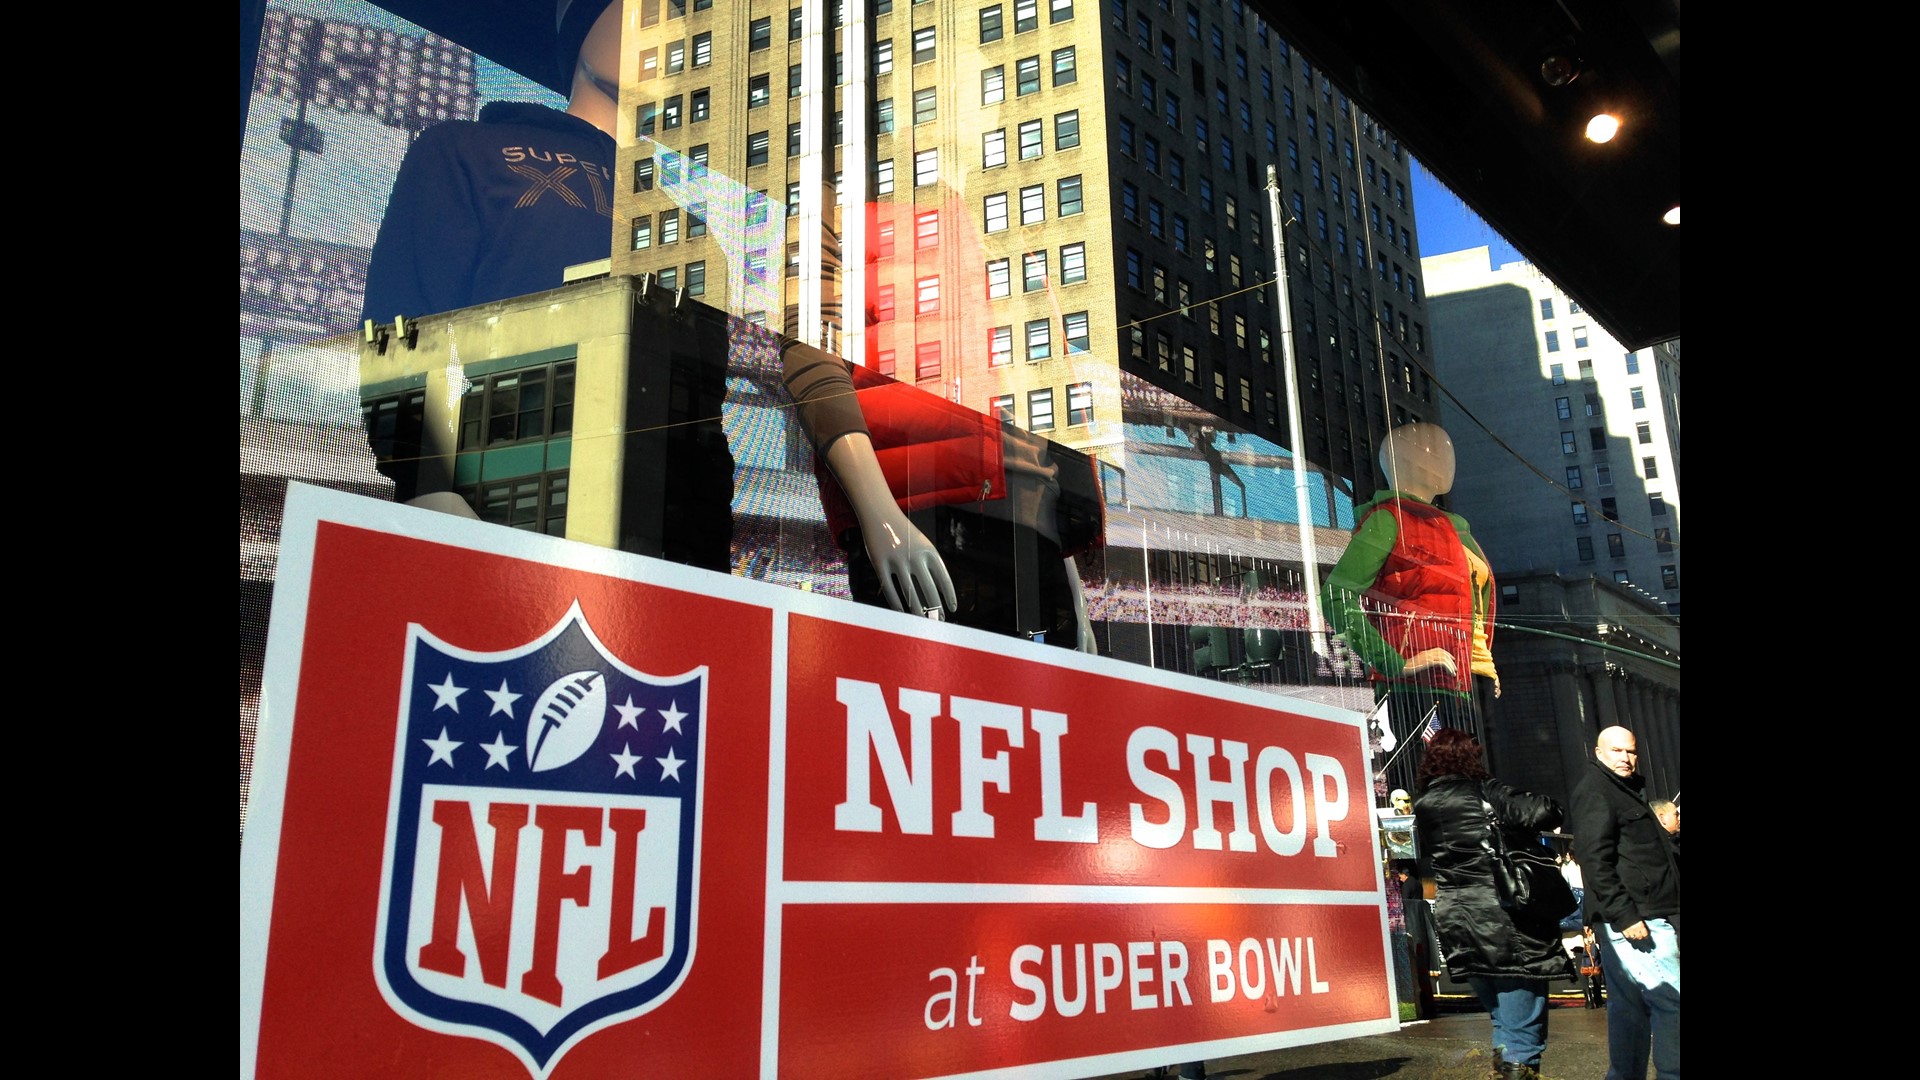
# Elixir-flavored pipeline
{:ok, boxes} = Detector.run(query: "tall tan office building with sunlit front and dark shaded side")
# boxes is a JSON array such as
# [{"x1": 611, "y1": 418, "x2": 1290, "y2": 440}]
[{"x1": 612, "y1": 0, "x2": 1434, "y2": 496}]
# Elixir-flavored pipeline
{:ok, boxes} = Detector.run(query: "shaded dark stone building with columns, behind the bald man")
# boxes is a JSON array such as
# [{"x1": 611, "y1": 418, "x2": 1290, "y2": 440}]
[{"x1": 1480, "y1": 571, "x2": 1680, "y2": 803}]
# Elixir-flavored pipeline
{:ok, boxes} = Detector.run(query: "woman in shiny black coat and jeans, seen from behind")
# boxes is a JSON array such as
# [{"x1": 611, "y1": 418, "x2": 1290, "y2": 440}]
[{"x1": 1413, "y1": 728, "x2": 1572, "y2": 1078}]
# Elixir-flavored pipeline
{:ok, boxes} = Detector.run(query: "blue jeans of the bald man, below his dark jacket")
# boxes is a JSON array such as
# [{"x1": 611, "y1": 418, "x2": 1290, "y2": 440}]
[{"x1": 1594, "y1": 919, "x2": 1680, "y2": 1080}]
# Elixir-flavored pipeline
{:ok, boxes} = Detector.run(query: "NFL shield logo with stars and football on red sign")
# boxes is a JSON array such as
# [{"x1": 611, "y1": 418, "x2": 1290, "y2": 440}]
[{"x1": 374, "y1": 603, "x2": 707, "y2": 1078}]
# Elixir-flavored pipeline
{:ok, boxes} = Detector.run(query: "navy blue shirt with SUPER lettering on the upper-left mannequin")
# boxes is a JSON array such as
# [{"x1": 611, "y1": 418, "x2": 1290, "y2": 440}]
[{"x1": 361, "y1": 102, "x2": 614, "y2": 323}]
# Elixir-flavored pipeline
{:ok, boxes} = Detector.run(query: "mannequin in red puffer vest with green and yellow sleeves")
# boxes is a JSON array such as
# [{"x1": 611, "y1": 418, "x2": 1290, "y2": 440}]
[{"x1": 1323, "y1": 423, "x2": 1498, "y2": 734}]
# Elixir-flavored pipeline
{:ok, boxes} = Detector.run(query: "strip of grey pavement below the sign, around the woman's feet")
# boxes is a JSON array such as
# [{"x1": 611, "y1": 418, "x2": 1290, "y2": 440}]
[{"x1": 1100, "y1": 1007, "x2": 1653, "y2": 1080}]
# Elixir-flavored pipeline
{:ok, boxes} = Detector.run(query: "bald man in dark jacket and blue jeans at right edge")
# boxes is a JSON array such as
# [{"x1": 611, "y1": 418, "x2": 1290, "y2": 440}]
[{"x1": 1569, "y1": 726, "x2": 1680, "y2": 1080}]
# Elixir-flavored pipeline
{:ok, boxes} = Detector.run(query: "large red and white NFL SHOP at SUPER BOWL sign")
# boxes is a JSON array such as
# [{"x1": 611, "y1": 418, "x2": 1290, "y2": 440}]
[{"x1": 240, "y1": 486, "x2": 1398, "y2": 1080}]
